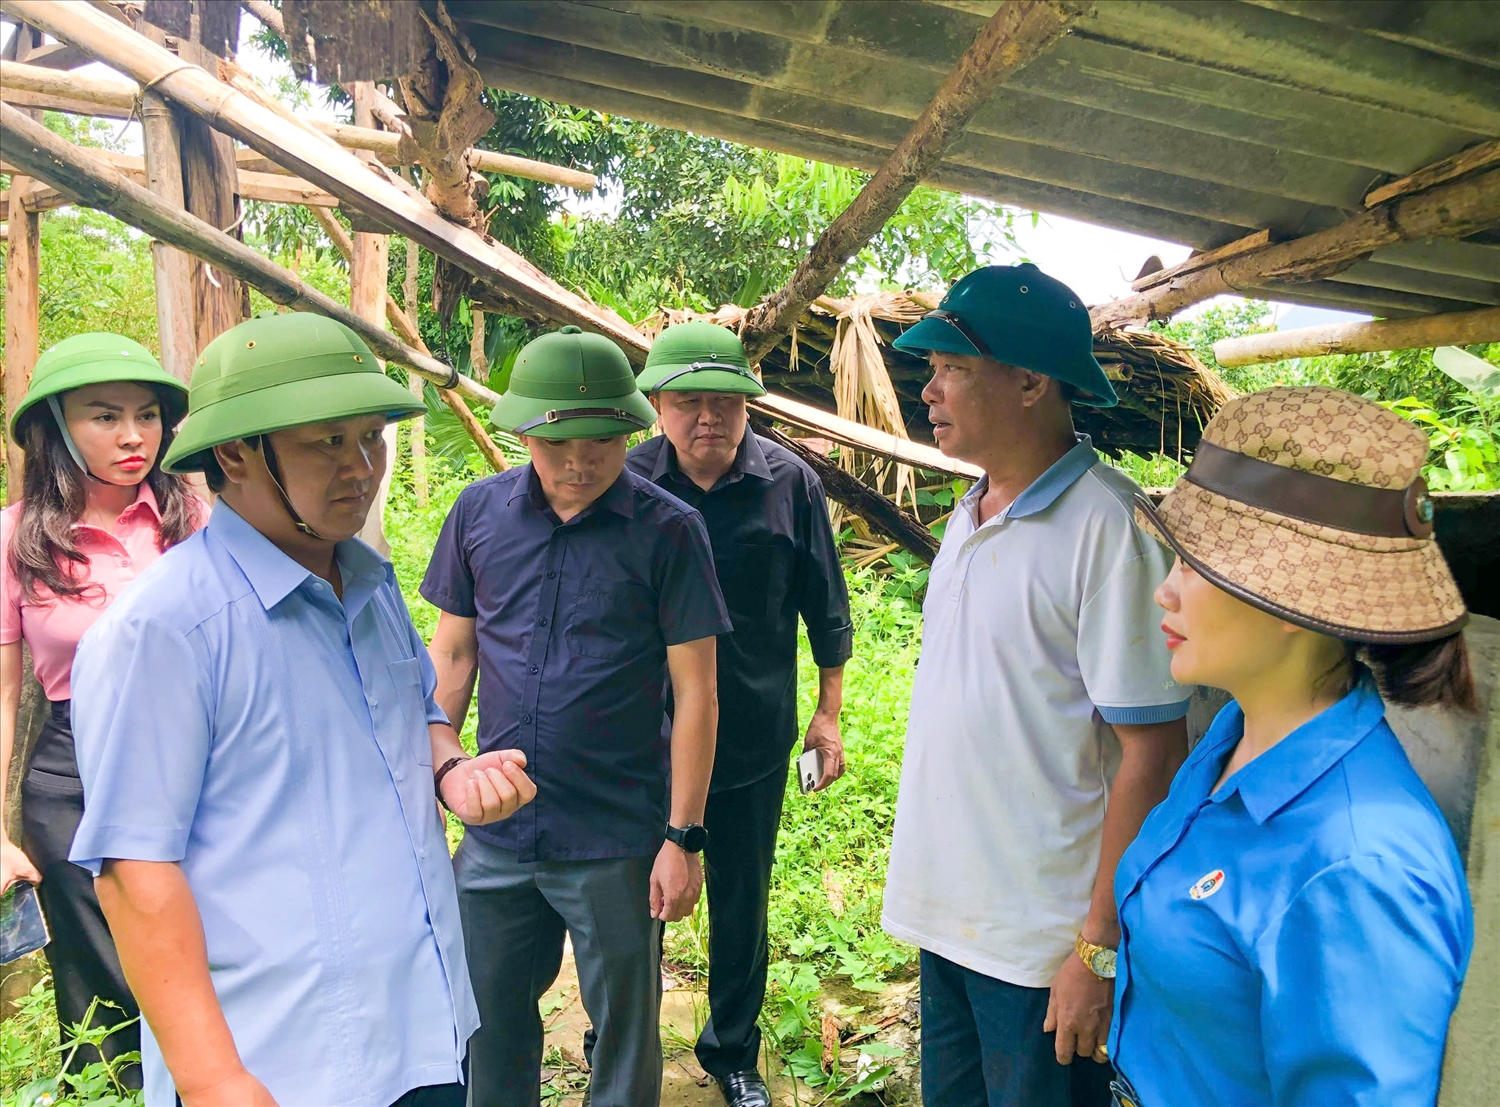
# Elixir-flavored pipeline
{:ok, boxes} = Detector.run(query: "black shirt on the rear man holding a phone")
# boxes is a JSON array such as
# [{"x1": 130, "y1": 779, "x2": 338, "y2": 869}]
[{"x1": 626, "y1": 431, "x2": 854, "y2": 792}]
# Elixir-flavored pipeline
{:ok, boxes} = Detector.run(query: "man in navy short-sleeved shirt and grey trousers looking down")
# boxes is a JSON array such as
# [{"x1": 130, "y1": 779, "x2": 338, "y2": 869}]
[{"x1": 422, "y1": 327, "x2": 731, "y2": 1107}]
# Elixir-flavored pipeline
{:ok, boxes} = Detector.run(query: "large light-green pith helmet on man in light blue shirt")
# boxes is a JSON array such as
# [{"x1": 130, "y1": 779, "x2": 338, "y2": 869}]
[{"x1": 162, "y1": 312, "x2": 426, "y2": 473}]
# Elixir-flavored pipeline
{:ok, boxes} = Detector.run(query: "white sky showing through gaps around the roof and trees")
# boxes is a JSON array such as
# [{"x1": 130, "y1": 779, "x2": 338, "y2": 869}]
[{"x1": 8, "y1": 14, "x2": 1370, "y2": 327}]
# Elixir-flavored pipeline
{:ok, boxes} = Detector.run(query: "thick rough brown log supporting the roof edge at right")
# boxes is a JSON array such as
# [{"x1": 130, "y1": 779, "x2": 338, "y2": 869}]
[{"x1": 1089, "y1": 168, "x2": 1500, "y2": 332}]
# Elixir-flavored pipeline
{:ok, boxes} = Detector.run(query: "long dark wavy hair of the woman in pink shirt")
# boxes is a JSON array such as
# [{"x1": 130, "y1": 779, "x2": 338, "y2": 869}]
[{"x1": 11, "y1": 393, "x2": 203, "y2": 603}]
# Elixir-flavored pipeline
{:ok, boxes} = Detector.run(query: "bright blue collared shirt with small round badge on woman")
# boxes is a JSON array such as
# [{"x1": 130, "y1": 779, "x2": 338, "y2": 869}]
[{"x1": 1110, "y1": 680, "x2": 1473, "y2": 1107}]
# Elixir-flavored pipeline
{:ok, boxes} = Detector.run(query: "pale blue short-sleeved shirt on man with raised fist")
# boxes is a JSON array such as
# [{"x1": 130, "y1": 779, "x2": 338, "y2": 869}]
[{"x1": 71, "y1": 500, "x2": 479, "y2": 1107}]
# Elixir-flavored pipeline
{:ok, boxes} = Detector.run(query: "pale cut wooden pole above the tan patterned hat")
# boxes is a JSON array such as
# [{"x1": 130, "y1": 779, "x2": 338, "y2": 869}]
[{"x1": 1214, "y1": 308, "x2": 1500, "y2": 368}]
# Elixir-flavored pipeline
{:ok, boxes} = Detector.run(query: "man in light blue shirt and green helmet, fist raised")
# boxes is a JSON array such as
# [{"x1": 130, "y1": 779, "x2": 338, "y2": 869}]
[{"x1": 69, "y1": 314, "x2": 536, "y2": 1107}]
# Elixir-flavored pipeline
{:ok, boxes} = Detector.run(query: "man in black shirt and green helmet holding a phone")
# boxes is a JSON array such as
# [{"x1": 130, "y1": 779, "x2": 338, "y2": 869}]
[{"x1": 626, "y1": 321, "x2": 852, "y2": 1107}]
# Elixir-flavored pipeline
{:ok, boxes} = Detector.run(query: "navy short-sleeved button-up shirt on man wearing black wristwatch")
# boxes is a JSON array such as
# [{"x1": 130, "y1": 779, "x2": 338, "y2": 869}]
[{"x1": 422, "y1": 465, "x2": 731, "y2": 861}]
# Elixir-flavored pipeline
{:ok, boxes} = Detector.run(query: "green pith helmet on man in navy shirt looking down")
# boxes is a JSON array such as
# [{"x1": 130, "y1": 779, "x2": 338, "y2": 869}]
[{"x1": 489, "y1": 327, "x2": 656, "y2": 438}]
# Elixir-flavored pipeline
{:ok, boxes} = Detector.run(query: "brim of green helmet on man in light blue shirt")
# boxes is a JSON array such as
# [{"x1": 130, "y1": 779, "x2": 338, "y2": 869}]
[{"x1": 162, "y1": 372, "x2": 428, "y2": 473}]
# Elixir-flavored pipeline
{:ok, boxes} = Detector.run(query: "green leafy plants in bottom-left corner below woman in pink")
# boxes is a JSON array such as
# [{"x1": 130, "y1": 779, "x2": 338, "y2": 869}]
[{"x1": 0, "y1": 980, "x2": 144, "y2": 1107}]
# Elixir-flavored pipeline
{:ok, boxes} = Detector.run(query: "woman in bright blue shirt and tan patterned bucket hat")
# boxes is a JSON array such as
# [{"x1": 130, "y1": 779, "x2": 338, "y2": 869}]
[{"x1": 1109, "y1": 387, "x2": 1475, "y2": 1107}]
